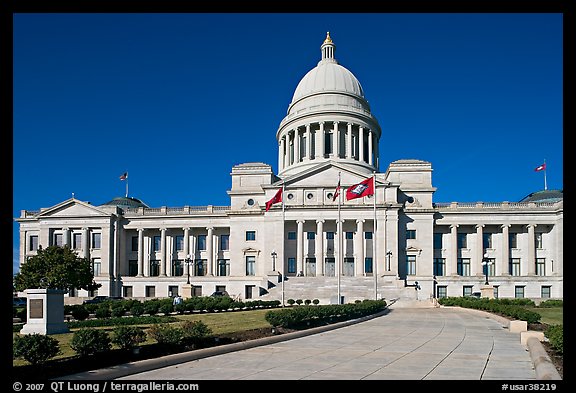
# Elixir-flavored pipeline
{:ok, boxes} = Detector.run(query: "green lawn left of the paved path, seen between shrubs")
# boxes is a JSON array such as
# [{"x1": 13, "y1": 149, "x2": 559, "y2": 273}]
[{"x1": 12, "y1": 309, "x2": 272, "y2": 366}]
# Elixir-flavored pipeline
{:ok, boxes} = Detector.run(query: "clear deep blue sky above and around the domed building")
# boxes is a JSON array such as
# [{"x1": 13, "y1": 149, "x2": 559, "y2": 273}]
[{"x1": 13, "y1": 13, "x2": 563, "y2": 272}]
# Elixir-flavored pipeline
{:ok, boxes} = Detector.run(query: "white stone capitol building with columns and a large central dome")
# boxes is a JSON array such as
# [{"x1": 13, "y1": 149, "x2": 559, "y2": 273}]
[{"x1": 15, "y1": 34, "x2": 564, "y2": 304}]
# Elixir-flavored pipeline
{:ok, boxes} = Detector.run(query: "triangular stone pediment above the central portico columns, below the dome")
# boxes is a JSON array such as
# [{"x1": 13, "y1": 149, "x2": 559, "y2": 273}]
[{"x1": 272, "y1": 161, "x2": 383, "y2": 189}]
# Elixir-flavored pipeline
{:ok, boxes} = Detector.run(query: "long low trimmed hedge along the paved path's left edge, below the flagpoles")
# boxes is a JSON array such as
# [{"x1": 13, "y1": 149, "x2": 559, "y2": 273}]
[{"x1": 265, "y1": 300, "x2": 386, "y2": 329}]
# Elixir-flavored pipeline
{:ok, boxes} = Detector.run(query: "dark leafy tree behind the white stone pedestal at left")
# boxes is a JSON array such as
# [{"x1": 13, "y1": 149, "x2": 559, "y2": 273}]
[{"x1": 14, "y1": 246, "x2": 101, "y2": 291}]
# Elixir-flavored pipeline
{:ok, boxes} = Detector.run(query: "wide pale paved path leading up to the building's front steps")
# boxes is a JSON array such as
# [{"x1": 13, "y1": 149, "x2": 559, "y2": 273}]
[{"x1": 119, "y1": 308, "x2": 536, "y2": 381}]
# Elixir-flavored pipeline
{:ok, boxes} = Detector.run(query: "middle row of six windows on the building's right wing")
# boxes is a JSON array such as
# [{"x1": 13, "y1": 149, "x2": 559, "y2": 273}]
[{"x1": 432, "y1": 255, "x2": 546, "y2": 276}]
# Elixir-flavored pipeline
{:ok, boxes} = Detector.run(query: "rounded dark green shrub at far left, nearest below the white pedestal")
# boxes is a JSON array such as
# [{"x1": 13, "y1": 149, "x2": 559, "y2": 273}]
[{"x1": 12, "y1": 333, "x2": 60, "y2": 365}]
